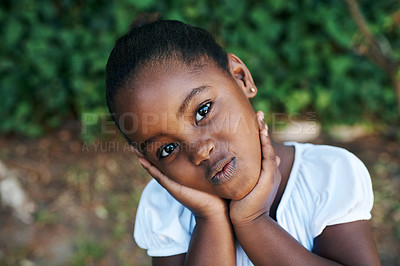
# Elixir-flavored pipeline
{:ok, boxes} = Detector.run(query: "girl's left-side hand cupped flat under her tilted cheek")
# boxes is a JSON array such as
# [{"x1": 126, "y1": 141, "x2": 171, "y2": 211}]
[{"x1": 133, "y1": 148, "x2": 228, "y2": 219}]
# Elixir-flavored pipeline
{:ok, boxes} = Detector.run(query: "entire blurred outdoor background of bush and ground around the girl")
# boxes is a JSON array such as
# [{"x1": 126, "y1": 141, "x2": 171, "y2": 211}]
[{"x1": 0, "y1": 0, "x2": 400, "y2": 266}]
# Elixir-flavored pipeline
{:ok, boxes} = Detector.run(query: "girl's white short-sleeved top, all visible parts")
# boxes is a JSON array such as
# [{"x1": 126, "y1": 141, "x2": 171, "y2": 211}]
[{"x1": 134, "y1": 142, "x2": 373, "y2": 265}]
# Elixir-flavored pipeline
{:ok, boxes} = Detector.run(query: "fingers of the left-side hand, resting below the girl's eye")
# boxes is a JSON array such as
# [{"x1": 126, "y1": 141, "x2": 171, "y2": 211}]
[{"x1": 138, "y1": 158, "x2": 188, "y2": 197}]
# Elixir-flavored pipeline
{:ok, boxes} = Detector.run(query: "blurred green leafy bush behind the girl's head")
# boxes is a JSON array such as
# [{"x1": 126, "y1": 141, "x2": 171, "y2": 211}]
[{"x1": 0, "y1": 0, "x2": 400, "y2": 136}]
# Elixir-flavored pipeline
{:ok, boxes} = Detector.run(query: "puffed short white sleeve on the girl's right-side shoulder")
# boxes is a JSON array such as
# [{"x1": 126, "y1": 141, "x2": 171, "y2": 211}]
[{"x1": 313, "y1": 148, "x2": 374, "y2": 237}]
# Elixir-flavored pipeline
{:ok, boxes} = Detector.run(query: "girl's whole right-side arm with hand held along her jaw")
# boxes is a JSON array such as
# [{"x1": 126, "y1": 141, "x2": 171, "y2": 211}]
[{"x1": 230, "y1": 112, "x2": 379, "y2": 265}]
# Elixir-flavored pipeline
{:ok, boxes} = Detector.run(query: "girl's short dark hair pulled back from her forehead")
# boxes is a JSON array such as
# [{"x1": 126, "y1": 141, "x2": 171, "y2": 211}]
[{"x1": 106, "y1": 20, "x2": 229, "y2": 143}]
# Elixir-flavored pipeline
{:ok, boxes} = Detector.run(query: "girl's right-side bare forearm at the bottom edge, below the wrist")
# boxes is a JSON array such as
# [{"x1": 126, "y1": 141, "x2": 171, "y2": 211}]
[{"x1": 233, "y1": 215, "x2": 339, "y2": 265}]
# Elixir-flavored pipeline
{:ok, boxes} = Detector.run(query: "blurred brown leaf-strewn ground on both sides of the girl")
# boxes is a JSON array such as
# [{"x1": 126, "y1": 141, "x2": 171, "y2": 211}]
[{"x1": 0, "y1": 122, "x2": 400, "y2": 265}]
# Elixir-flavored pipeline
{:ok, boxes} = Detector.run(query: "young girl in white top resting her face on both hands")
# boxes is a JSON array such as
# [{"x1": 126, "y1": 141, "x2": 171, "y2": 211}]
[{"x1": 107, "y1": 21, "x2": 380, "y2": 266}]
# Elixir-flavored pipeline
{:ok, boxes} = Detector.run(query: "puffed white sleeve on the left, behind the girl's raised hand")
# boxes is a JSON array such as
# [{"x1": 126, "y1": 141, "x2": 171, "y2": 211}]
[{"x1": 134, "y1": 179, "x2": 195, "y2": 257}]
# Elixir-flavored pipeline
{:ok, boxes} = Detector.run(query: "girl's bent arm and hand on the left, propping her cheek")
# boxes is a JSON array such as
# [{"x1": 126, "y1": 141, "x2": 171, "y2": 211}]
[{"x1": 138, "y1": 154, "x2": 236, "y2": 265}]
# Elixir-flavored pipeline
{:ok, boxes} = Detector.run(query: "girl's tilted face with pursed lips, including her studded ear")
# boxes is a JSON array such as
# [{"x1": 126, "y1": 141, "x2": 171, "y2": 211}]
[{"x1": 117, "y1": 55, "x2": 261, "y2": 199}]
